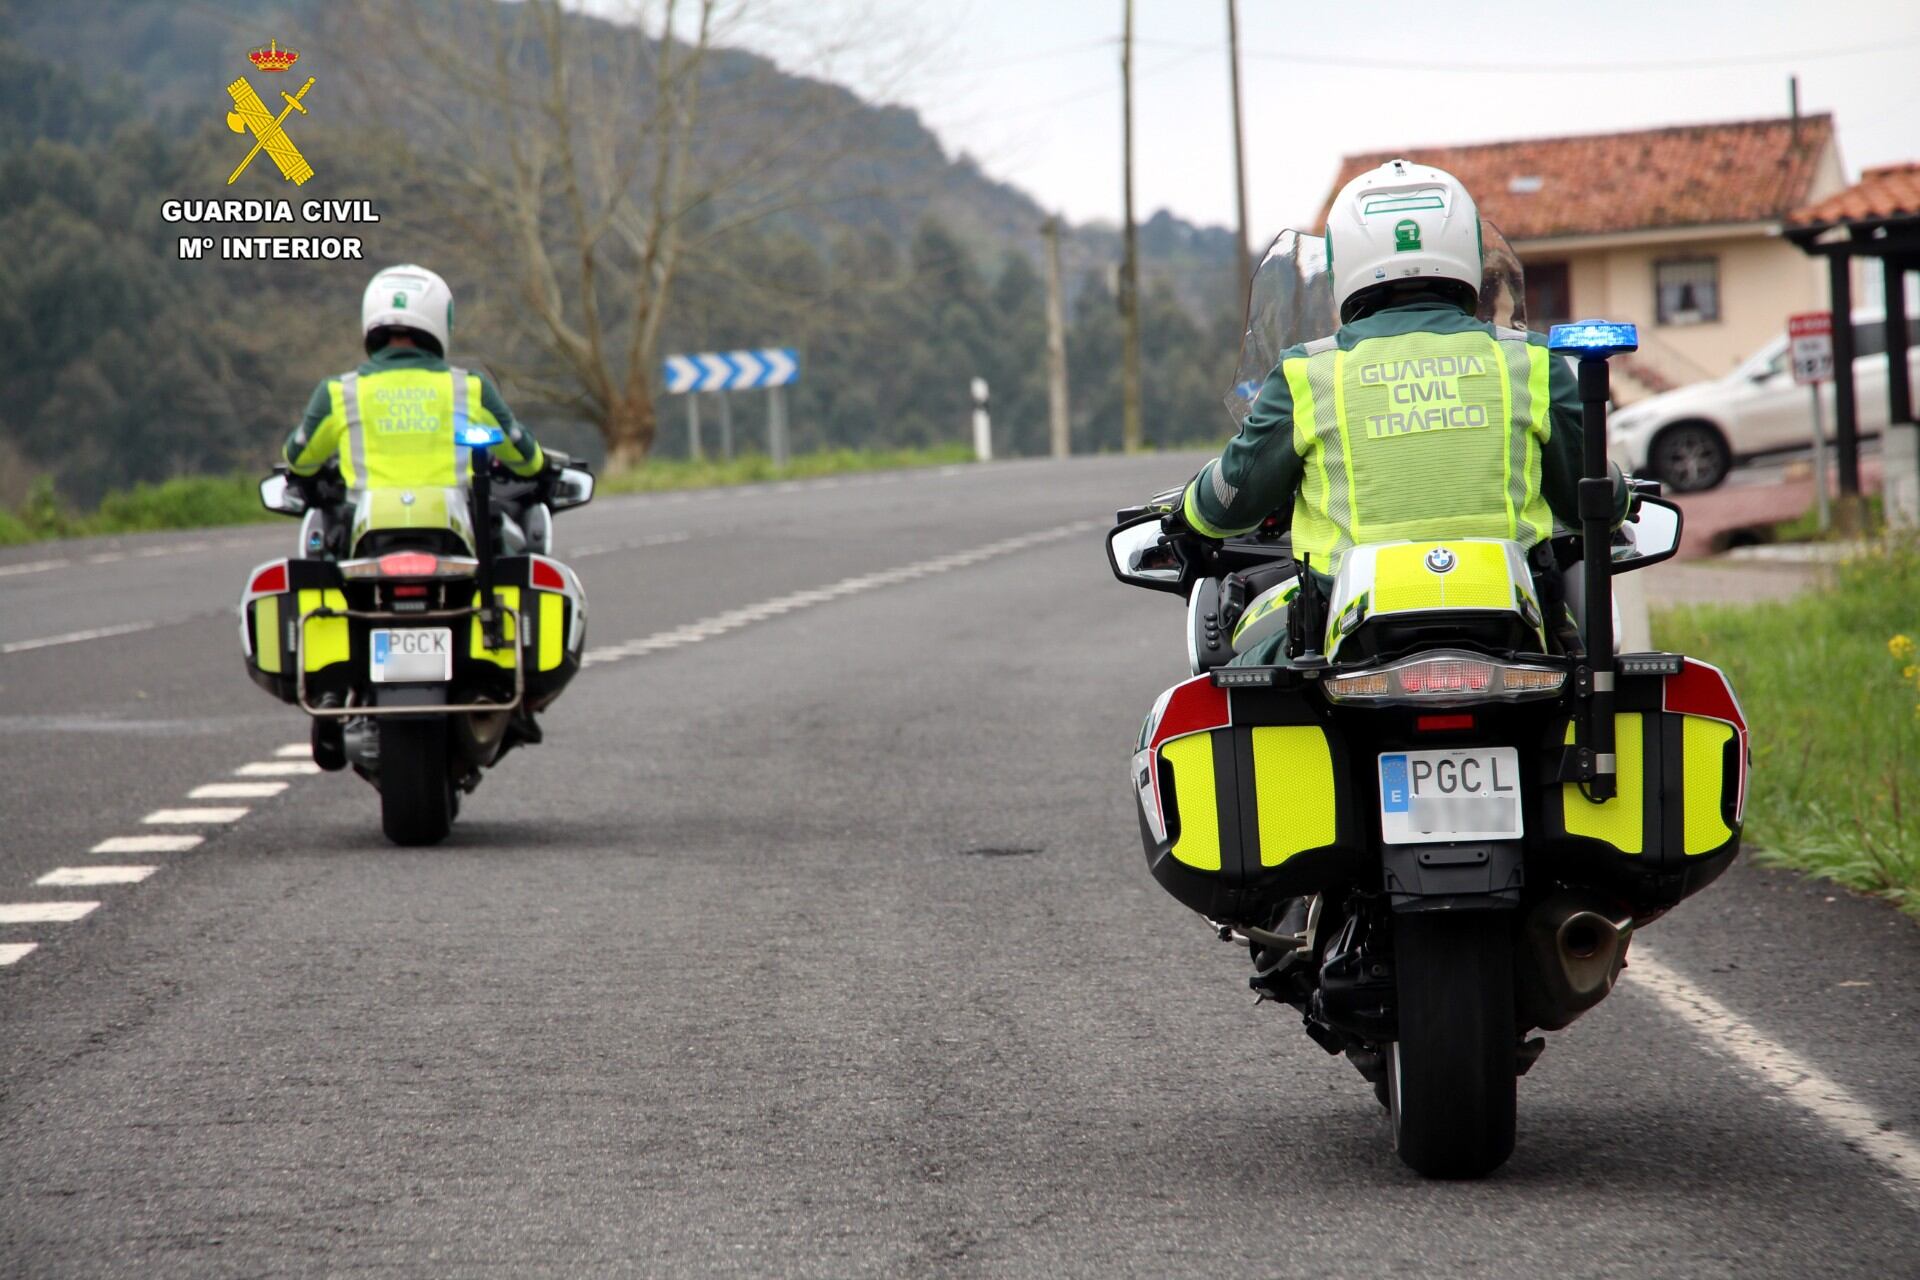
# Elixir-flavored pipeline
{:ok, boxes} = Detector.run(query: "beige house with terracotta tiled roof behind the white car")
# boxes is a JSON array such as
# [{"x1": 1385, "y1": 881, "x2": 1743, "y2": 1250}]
[{"x1": 1321, "y1": 115, "x2": 1847, "y2": 401}]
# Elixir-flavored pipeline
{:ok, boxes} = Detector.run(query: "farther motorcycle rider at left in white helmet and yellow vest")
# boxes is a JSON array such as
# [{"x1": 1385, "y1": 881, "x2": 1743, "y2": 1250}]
[{"x1": 286, "y1": 265, "x2": 545, "y2": 552}]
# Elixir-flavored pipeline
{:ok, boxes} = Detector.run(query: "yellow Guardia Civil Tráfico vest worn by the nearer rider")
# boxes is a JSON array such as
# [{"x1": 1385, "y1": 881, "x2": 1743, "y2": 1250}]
[{"x1": 1283, "y1": 330, "x2": 1553, "y2": 572}]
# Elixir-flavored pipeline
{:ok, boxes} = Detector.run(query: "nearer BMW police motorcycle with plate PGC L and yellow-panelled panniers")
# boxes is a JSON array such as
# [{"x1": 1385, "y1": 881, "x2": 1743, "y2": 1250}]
[{"x1": 1108, "y1": 233, "x2": 1749, "y2": 1178}]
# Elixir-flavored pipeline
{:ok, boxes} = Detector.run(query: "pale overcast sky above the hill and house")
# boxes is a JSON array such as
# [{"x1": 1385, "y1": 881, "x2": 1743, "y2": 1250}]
[{"x1": 714, "y1": 0, "x2": 1920, "y2": 240}]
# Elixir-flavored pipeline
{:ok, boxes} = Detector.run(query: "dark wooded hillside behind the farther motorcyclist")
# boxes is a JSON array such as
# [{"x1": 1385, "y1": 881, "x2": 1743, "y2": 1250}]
[{"x1": 0, "y1": 0, "x2": 1236, "y2": 503}]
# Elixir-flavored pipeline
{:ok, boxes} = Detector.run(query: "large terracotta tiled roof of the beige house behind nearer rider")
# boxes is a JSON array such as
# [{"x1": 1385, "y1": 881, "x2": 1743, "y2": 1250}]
[{"x1": 1321, "y1": 113, "x2": 1834, "y2": 240}]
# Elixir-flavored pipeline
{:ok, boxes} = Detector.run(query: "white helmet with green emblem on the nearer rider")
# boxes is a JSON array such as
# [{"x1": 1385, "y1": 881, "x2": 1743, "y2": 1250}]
[{"x1": 1327, "y1": 159, "x2": 1480, "y2": 322}]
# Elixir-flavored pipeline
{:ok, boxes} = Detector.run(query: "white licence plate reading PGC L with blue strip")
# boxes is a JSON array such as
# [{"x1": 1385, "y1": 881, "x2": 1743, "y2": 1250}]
[{"x1": 1380, "y1": 747, "x2": 1521, "y2": 844}]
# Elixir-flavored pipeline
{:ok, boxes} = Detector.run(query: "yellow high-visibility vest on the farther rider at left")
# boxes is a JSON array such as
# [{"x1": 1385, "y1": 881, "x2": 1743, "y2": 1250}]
[{"x1": 328, "y1": 368, "x2": 487, "y2": 489}]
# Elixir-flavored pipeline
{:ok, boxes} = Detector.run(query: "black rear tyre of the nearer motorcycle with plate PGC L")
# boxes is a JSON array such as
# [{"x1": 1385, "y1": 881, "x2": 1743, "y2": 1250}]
[{"x1": 1386, "y1": 910, "x2": 1519, "y2": 1178}]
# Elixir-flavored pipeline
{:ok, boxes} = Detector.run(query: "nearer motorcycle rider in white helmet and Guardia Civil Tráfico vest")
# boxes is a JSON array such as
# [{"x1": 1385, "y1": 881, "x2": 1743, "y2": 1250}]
[{"x1": 1173, "y1": 159, "x2": 1628, "y2": 664}]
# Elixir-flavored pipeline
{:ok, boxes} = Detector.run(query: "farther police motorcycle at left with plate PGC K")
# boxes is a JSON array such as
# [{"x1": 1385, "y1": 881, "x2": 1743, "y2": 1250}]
[{"x1": 240, "y1": 422, "x2": 593, "y2": 844}]
